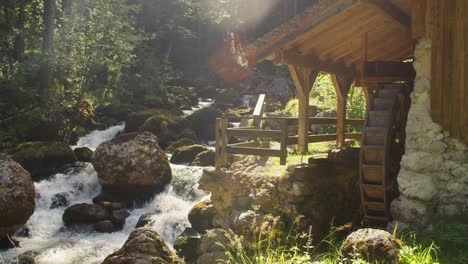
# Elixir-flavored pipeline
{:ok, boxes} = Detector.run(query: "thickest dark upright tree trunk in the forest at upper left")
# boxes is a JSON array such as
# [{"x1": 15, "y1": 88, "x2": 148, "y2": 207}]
[{"x1": 41, "y1": 0, "x2": 56, "y2": 105}]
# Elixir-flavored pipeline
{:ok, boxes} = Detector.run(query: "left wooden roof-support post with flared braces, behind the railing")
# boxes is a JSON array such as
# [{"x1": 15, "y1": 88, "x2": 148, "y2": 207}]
[{"x1": 288, "y1": 65, "x2": 318, "y2": 154}]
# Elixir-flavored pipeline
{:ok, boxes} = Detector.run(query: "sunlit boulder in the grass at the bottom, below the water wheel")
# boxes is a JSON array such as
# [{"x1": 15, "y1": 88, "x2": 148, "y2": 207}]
[{"x1": 340, "y1": 228, "x2": 402, "y2": 264}]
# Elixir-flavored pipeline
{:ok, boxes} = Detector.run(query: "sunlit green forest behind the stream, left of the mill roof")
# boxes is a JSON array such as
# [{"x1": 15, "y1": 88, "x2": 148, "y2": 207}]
[{"x1": 0, "y1": 0, "x2": 322, "y2": 148}]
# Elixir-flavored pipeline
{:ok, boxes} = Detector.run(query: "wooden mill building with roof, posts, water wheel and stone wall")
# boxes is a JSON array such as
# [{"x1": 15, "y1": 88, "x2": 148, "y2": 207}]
[{"x1": 219, "y1": 0, "x2": 468, "y2": 223}]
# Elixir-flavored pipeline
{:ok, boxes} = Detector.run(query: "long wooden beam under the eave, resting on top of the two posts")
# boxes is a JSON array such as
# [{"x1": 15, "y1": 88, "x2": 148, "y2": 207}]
[{"x1": 273, "y1": 50, "x2": 355, "y2": 76}]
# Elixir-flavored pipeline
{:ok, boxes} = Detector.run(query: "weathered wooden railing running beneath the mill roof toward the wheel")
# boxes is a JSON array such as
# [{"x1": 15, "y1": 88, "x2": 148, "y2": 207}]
[{"x1": 216, "y1": 116, "x2": 364, "y2": 167}]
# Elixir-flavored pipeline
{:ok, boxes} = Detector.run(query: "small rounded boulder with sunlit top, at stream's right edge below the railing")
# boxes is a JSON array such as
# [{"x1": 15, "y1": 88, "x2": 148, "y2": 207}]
[{"x1": 188, "y1": 200, "x2": 217, "y2": 233}]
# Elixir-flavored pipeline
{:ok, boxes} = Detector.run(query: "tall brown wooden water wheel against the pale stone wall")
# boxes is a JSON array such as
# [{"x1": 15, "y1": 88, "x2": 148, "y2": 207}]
[{"x1": 360, "y1": 83, "x2": 409, "y2": 224}]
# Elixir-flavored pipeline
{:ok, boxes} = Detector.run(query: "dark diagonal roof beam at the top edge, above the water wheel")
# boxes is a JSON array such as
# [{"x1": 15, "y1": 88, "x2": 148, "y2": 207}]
[{"x1": 360, "y1": 0, "x2": 411, "y2": 33}]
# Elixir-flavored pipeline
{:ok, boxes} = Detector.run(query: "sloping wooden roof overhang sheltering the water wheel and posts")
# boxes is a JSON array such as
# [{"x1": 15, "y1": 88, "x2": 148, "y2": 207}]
[{"x1": 247, "y1": 0, "x2": 414, "y2": 74}]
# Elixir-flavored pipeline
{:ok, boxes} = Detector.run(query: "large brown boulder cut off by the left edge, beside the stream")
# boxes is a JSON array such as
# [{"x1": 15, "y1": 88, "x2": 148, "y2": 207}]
[{"x1": 0, "y1": 155, "x2": 35, "y2": 245}]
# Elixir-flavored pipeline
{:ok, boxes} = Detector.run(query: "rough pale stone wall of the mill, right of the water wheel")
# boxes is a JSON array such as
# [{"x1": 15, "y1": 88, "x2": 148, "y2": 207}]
[{"x1": 391, "y1": 39, "x2": 468, "y2": 227}]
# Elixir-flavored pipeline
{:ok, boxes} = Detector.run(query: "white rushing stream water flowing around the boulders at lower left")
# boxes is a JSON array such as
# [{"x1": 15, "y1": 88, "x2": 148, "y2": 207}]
[{"x1": 0, "y1": 124, "x2": 207, "y2": 264}]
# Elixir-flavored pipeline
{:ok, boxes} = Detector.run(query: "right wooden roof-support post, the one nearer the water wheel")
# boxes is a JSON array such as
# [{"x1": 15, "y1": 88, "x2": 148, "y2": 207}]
[{"x1": 332, "y1": 74, "x2": 353, "y2": 148}]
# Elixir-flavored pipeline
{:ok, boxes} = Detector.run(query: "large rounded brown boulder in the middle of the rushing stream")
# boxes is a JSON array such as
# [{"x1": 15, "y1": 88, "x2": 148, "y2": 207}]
[{"x1": 93, "y1": 132, "x2": 172, "y2": 202}]
